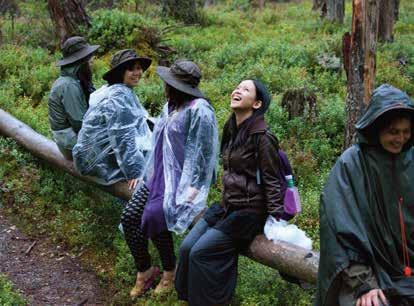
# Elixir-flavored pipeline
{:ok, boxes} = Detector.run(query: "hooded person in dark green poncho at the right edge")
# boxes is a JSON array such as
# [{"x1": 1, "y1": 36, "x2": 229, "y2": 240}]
[{"x1": 315, "y1": 84, "x2": 414, "y2": 306}]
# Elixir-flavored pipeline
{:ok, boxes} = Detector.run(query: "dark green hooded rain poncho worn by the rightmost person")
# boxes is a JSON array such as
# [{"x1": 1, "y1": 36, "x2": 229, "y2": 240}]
[{"x1": 315, "y1": 85, "x2": 414, "y2": 306}]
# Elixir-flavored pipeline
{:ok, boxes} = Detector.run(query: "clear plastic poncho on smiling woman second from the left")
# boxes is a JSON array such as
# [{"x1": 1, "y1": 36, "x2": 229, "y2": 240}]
[{"x1": 73, "y1": 84, "x2": 152, "y2": 185}]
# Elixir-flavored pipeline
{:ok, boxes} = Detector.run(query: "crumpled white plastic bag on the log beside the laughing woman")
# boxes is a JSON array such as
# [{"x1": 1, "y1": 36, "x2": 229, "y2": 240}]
[{"x1": 264, "y1": 216, "x2": 312, "y2": 250}]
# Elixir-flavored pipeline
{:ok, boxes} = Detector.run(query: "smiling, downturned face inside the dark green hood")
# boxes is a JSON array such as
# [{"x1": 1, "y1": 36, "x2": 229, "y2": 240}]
[{"x1": 379, "y1": 118, "x2": 411, "y2": 154}]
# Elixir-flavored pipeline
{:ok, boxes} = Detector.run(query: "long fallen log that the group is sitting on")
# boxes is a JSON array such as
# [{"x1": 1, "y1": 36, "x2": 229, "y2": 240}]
[{"x1": 0, "y1": 109, "x2": 319, "y2": 284}]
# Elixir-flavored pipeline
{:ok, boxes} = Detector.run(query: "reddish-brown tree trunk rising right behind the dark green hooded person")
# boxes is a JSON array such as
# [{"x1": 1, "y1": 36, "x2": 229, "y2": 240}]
[{"x1": 343, "y1": 0, "x2": 379, "y2": 148}]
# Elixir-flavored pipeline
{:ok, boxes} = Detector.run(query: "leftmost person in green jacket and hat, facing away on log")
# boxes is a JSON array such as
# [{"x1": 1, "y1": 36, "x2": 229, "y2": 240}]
[{"x1": 48, "y1": 36, "x2": 99, "y2": 160}]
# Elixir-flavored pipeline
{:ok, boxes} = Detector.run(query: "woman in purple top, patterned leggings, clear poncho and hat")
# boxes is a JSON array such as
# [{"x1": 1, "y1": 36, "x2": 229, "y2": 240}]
[{"x1": 121, "y1": 61, "x2": 218, "y2": 297}]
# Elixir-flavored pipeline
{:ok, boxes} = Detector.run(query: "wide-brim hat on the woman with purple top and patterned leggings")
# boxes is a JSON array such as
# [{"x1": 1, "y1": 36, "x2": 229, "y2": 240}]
[{"x1": 157, "y1": 60, "x2": 205, "y2": 98}]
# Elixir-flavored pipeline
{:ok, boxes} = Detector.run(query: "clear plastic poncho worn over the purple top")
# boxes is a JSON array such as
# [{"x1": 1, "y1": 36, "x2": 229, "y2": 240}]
[{"x1": 145, "y1": 99, "x2": 218, "y2": 234}]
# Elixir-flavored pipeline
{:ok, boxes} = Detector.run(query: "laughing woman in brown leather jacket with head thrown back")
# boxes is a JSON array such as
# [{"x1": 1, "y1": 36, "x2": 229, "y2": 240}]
[{"x1": 175, "y1": 80, "x2": 284, "y2": 306}]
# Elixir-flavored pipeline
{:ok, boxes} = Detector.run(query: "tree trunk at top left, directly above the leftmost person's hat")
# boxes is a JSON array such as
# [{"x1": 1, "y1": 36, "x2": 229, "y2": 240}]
[{"x1": 47, "y1": 0, "x2": 91, "y2": 42}]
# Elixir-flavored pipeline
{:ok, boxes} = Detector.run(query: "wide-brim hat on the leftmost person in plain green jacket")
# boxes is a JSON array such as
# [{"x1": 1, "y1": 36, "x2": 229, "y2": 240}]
[{"x1": 56, "y1": 36, "x2": 100, "y2": 67}]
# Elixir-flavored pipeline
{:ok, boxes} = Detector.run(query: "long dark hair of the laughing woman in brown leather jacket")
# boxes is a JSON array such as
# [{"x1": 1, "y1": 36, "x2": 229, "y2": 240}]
[{"x1": 220, "y1": 80, "x2": 270, "y2": 153}]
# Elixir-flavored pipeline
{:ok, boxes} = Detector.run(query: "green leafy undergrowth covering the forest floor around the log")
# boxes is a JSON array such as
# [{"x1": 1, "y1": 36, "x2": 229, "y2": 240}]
[{"x1": 0, "y1": 0, "x2": 414, "y2": 305}]
